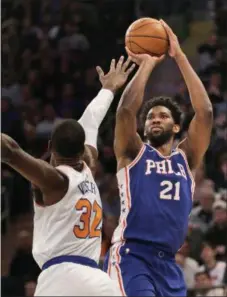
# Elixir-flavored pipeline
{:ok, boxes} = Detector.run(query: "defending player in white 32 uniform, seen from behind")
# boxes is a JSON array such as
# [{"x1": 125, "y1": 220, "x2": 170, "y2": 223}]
[{"x1": 1, "y1": 58, "x2": 134, "y2": 296}]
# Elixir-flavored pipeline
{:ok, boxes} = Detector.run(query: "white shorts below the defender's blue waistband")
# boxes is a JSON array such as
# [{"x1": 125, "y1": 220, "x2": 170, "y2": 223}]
[{"x1": 34, "y1": 263, "x2": 121, "y2": 296}]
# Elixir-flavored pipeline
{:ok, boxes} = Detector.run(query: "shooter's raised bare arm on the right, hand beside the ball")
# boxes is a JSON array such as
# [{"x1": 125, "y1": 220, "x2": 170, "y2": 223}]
[{"x1": 161, "y1": 21, "x2": 213, "y2": 169}]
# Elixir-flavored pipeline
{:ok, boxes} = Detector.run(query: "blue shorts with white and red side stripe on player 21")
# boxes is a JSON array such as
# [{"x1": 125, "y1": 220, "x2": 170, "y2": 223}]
[{"x1": 104, "y1": 241, "x2": 187, "y2": 297}]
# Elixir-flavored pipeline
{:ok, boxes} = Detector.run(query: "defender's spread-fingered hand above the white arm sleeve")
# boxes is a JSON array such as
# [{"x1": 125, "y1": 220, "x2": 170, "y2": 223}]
[{"x1": 96, "y1": 56, "x2": 136, "y2": 93}]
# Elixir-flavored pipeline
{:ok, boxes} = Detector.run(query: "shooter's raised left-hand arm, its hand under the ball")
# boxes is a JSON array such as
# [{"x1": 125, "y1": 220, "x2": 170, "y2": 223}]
[{"x1": 114, "y1": 49, "x2": 163, "y2": 164}]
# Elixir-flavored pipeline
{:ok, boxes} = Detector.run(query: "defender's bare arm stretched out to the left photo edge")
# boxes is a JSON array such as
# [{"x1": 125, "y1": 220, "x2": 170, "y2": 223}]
[{"x1": 1, "y1": 133, "x2": 68, "y2": 205}]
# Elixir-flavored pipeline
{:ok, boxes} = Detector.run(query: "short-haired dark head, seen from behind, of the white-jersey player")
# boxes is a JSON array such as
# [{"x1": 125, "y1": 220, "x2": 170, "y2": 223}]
[{"x1": 51, "y1": 119, "x2": 85, "y2": 158}]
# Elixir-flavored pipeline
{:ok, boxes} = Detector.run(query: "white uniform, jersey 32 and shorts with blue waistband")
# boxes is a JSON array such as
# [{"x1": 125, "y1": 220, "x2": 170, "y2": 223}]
[{"x1": 33, "y1": 165, "x2": 119, "y2": 296}]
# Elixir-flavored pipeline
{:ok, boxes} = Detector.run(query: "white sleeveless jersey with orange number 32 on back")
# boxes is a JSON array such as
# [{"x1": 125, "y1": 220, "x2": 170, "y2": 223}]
[{"x1": 33, "y1": 165, "x2": 102, "y2": 267}]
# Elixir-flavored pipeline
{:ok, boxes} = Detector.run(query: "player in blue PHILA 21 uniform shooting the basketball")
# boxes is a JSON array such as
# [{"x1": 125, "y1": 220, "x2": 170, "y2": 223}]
[{"x1": 104, "y1": 22, "x2": 212, "y2": 296}]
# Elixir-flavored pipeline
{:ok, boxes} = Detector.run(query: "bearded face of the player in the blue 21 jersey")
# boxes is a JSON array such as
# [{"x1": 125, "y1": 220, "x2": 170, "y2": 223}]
[{"x1": 144, "y1": 106, "x2": 180, "y2": 147}]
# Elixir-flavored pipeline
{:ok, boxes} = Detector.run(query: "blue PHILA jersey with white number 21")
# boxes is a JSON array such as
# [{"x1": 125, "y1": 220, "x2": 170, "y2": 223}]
[{"x1": 112, "y1": 144, "x2": 194, "y2": 254}]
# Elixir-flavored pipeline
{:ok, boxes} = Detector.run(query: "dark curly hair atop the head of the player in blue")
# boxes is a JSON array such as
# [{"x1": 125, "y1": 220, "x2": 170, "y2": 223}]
[{"x1": 140, "y1": 97, "x2": 182, "y2": 127}]
